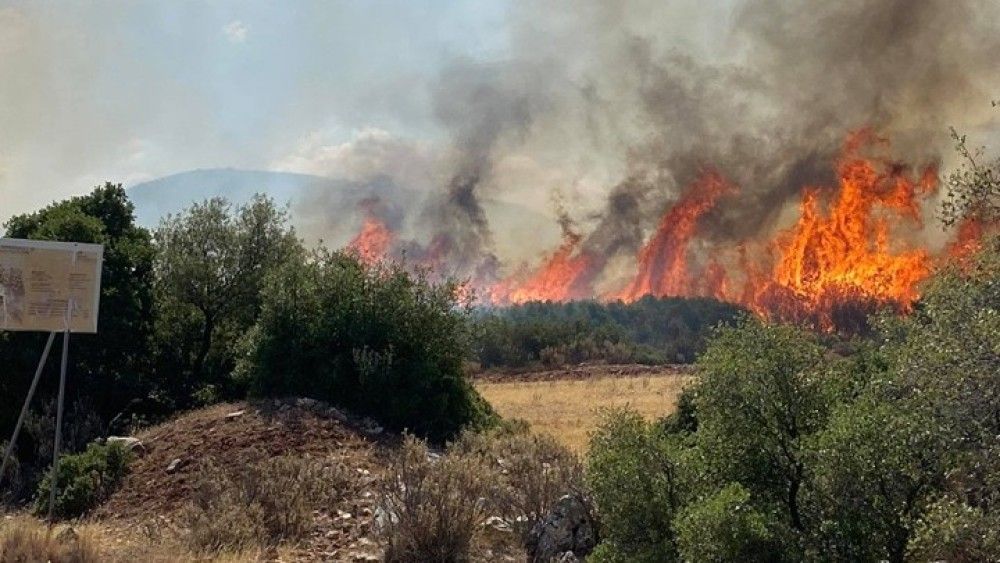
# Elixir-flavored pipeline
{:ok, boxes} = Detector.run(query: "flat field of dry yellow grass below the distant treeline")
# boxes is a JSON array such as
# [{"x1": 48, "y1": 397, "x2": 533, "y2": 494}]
[{"x1": 476, "y1": 375, "x2": 690, "y2": 453}]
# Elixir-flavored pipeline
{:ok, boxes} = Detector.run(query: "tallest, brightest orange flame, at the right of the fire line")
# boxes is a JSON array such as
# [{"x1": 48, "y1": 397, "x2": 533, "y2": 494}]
[{"x1": 744, "y1": 130, "x2": 937, "y2": 329}]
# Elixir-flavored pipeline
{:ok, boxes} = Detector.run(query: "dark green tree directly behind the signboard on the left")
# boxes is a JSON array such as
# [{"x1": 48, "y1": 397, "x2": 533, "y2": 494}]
[{"x1": 0, "y1": 184, "x2": 155, "y2": 450}]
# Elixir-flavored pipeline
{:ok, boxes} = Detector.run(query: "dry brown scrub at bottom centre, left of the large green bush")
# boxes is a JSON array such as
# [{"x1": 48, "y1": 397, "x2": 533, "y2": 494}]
[{"x1": 378, "y1": 427, "x2": 587, "y2": 562}]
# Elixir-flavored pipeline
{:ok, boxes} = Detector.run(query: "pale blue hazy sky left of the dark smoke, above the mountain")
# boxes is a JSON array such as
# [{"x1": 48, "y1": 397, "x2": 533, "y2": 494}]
[{"x1": 0, "y1": 0, "x2": 508, "y2": 217}]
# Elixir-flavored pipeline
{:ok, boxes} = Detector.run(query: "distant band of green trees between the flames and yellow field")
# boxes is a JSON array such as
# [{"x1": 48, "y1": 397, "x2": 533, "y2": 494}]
[{"x1": 474, "y1": 297, "x2": 742, "y2": 368}]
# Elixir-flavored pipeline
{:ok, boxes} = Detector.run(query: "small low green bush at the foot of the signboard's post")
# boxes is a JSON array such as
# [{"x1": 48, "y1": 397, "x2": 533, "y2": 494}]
[{"x1": 35, "y1": 443, "x2": 131, "y2": 518}]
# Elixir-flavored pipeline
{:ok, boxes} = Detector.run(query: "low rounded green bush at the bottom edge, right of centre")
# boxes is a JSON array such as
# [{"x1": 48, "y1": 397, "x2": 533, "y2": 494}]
[{"x1": 673, "y1": 483, "x2": 785, "y2": 563}]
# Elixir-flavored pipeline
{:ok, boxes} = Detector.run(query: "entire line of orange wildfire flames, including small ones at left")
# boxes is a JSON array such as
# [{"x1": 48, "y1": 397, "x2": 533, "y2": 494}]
[{"x1": 349, "y1": 129, "x2": 985, "y2": 330}]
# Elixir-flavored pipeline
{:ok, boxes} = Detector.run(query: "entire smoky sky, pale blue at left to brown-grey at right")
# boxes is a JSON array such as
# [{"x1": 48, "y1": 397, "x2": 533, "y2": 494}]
[{"x1": 0, "y1": 0, "x2": 1000, "y2": 295}]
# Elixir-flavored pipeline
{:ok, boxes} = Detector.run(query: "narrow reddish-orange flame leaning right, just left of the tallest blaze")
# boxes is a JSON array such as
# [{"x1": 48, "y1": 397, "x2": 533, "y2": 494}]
[{"x1": 618, "y1": 170, "x2": 735, "y2": 301}]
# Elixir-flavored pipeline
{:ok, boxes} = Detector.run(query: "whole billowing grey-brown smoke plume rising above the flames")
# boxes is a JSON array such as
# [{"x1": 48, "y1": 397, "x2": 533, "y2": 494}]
[{"x1": 292, "y1": 0, "x2": 1000, "y2": 288}]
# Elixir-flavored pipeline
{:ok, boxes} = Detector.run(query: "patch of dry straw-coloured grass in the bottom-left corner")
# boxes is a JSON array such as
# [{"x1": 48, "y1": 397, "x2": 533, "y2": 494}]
[{"x1": 0, "y1": 518, "x2": 103, "y2": 563}]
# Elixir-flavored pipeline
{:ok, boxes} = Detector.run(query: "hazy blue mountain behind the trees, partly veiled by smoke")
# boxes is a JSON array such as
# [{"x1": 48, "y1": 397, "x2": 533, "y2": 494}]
[{"x1": 128, "y1": 168, "x2": 559, "y2": 260}]
